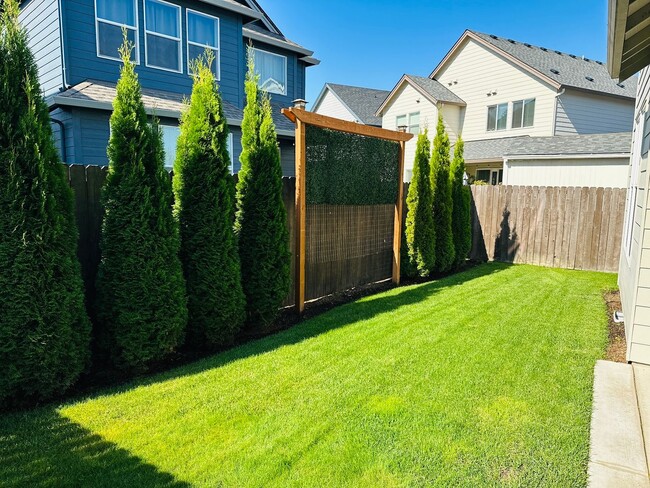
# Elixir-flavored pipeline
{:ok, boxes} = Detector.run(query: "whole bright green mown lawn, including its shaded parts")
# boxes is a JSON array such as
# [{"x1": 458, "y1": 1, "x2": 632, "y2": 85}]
[{"x1": 0, "y1": 264, "x2": 615, "y2": 487}]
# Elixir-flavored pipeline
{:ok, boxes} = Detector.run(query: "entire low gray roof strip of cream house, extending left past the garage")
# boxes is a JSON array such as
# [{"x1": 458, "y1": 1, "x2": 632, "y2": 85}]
[{"x1": 465, "y1": 132, "x2": 632, "y2": 162}]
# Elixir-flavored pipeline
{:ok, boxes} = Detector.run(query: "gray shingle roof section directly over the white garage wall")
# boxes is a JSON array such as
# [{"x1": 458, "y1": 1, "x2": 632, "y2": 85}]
[{"x1": 506, "y1": 132, "x2": 632, "y2": 157}]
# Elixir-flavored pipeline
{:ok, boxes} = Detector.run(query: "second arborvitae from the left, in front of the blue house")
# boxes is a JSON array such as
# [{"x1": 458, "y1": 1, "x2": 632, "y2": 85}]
[{"x1": 97, "y1": 39, "x2": 187, "y2": 371}]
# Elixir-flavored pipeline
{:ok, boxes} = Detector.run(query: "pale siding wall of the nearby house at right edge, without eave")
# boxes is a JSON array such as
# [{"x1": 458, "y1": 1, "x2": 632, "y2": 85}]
[{"x1": 618, "y1": 68, "x2": 650, "y2": 364}]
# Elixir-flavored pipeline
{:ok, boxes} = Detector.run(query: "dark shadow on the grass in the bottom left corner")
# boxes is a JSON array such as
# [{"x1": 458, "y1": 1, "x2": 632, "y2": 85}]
[{"x1": 0, "y1": 408, "x2": 190, "y2": 488}]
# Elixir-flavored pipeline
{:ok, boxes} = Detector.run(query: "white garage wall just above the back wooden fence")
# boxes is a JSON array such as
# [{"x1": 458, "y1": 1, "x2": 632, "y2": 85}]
[{"x1": 503, "y1": 158, "x2": 629, "y2": 188}]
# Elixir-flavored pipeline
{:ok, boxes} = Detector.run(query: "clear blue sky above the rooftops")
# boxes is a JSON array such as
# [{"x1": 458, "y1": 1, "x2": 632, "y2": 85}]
[{"x1": 259, "y1": 0, "x2": 607, "y2": 107}]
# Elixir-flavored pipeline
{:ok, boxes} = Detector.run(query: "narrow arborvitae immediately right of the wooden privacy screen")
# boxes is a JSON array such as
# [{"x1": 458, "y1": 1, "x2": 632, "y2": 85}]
[{"x1": 406, "y1": 129, "x2": 436, "y2": 276}]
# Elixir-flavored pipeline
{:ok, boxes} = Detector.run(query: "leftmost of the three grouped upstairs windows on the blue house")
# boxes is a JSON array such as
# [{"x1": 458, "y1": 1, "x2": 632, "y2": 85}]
[{"x1": 95, "y1": 0, "x2": 140, "y2": 63}]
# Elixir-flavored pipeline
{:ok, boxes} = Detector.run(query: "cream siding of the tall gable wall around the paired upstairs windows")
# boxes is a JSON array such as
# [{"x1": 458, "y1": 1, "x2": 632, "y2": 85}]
[{"x1": 436, "y1": 39, "x2": 557, "y2": 141}]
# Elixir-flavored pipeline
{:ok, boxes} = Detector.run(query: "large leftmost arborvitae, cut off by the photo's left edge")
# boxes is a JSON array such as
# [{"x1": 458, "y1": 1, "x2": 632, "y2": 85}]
[{"x1": 0, "y1": 0, "x2": 90, "y2": 407}]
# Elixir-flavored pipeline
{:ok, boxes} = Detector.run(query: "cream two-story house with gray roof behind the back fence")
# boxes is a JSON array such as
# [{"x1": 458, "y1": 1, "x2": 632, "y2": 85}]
[{"x1": 377, "y1": 30, "x2": 636, "y2": 187}]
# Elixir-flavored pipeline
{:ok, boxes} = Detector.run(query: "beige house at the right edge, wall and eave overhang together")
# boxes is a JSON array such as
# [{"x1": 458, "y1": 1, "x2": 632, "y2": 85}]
[{"x1": 607, "y1": 0, "x2": 650, "y2": 364}]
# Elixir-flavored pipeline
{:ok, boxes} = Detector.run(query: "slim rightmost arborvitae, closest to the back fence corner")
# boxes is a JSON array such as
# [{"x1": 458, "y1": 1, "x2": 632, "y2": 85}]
[{"x1": 449, "y1": 136, "x2": 472, "y2": 267}]
